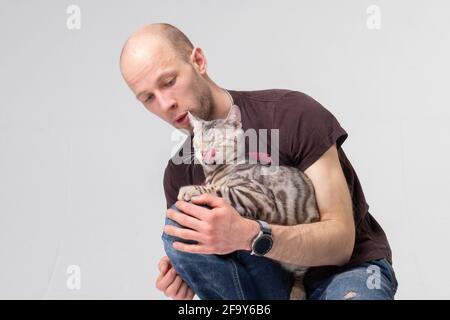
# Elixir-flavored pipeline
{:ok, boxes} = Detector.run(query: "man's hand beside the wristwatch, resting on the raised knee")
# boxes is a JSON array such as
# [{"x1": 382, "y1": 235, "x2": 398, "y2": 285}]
[{"x1": 164, "y1": 194, "x2": 259, "y2": 254}]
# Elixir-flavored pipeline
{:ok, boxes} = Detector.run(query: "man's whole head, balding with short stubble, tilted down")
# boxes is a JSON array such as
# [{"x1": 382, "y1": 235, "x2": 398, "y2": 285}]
[{"x1": 120, "y1": 23, "x2": 213, "y2": 131}]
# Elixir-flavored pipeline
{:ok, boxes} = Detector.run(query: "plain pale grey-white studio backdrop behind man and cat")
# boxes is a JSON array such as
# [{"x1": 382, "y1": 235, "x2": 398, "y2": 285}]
[{"x1": 0, "y1": 0, "x2": 450, "y2": 299}]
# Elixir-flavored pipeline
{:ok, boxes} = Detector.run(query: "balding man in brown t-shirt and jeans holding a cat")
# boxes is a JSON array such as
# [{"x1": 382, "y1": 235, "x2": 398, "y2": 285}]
[{"x1": 120, "y1": 23, "x2": 397, "y2": 299}]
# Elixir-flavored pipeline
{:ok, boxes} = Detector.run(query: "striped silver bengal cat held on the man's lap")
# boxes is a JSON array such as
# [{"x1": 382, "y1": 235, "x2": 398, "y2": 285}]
[{"x1": 178, "y1": 104, "x2": 319, "y2": 300}]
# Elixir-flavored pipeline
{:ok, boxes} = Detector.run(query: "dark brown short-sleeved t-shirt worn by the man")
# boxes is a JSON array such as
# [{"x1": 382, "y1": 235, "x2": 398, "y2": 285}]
[{"x1": 164, "y1": 89, "x2": 392, "y2": 285}]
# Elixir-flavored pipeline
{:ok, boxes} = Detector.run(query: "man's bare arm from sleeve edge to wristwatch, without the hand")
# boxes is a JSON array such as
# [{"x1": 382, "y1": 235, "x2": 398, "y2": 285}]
[{"x1": 245, "y1": 144, "x2": 355, "y2": 266}]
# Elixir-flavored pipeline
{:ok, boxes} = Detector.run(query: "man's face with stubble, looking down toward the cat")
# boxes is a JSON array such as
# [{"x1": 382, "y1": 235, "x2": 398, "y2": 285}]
[{"x1": 121, "y1": 43, "x2": 212, "y2": 132}]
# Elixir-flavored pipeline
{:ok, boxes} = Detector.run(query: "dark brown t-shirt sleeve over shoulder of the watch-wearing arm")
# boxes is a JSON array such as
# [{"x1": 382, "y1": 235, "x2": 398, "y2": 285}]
[{"x1": 283, "y1": 91, "x2": 348, "y2": 172}]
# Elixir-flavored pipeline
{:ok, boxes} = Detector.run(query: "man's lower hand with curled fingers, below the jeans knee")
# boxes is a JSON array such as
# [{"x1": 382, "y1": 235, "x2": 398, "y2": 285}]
[{"x1": 156, "y1": 256, "x2": 194, "y2": 300}]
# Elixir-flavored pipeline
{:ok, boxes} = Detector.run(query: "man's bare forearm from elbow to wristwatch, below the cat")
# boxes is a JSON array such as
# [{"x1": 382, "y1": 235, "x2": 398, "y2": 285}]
[{"x1": 241, "y1": 220, "x2": 354, "y2": 267}]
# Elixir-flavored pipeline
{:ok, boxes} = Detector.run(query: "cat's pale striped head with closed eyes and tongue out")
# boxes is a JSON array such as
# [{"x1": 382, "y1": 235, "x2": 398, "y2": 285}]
[{"x1": 188, "y1": 105, "x2": 245, "y2": 166}]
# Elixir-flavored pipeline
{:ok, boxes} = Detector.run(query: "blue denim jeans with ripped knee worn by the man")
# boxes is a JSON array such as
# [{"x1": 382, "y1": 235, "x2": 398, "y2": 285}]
[{"x1": 162, "y1": 205, "x2": 397, "y2": 300}]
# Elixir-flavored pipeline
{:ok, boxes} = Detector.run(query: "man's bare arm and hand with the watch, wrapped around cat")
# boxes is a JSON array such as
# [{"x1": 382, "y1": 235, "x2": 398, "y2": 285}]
[{"x1": 164, "y1": 145, "x2": 355, "y2": 267}]
